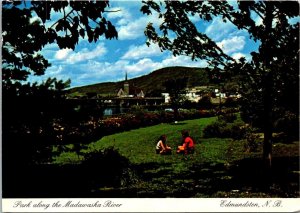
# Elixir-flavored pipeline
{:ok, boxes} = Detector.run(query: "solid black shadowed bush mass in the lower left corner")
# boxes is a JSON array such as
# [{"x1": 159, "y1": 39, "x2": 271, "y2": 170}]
[{"x1": 3, "y1": 147, "x2": 134, "y2": 198}]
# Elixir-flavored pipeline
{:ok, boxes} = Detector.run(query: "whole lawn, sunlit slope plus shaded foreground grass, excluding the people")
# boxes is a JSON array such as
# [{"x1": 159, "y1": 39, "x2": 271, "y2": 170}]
[{"x1": 55, "y1": 117, "x2": 299, "y2": 197}]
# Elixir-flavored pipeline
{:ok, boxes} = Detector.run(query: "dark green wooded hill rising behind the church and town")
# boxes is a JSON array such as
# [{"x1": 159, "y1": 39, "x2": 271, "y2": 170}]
[{"x1": 69, "y1": 67, "x2": 209, "y2": 96}]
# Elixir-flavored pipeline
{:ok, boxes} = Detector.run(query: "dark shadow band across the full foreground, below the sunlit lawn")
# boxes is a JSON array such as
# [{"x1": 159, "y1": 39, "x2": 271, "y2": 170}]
[{"x1": 3, "y1": 157, "x2": 299, "y2": 198}]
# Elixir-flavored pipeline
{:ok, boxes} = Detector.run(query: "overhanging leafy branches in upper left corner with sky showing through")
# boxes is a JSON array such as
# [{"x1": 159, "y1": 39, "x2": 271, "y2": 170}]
[{"x1": 2, "y1": 1, "x2": 117, "y2": 89}]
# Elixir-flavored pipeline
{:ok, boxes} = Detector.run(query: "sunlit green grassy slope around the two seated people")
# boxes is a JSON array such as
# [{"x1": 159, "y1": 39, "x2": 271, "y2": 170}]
[{"x1": 83, "y1": 118, "x2": 247, "y2": 166}]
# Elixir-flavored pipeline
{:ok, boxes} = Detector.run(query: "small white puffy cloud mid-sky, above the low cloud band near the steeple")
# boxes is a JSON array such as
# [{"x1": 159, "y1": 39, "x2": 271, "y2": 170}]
[{"x1": 121, "y1": 44, "x2": 163, "y2": 59}]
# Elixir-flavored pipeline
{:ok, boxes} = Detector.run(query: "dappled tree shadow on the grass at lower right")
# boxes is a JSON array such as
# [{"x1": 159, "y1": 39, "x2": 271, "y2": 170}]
[{"x1": 130, "y1": 157, "x2": 299, "y2": 198}]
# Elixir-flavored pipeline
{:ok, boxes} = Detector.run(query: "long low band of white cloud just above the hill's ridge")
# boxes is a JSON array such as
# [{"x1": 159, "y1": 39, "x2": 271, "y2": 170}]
[{"x1": 31, "y1": 53, "x2": 206, "y2": 87}]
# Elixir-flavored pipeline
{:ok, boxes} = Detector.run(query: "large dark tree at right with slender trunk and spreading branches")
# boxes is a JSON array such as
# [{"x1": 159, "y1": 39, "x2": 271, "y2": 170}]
[{"x1": 141, "y1": 1, "x2": 299, "y2": 166}]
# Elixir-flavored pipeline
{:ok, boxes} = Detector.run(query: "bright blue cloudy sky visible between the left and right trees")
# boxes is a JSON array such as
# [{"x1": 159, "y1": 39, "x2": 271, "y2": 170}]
[{"x1": 30, "y1": 0, "x2": 261, "y2": 87}]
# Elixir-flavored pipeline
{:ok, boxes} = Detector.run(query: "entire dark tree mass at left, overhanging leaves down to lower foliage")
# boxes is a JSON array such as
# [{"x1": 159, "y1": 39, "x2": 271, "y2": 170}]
[{"x1": 2, "y1": 1, "x2": 117, "y2": 163}]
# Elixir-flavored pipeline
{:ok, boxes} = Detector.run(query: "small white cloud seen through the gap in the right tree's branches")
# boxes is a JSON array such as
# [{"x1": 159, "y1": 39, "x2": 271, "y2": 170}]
[{"x1": 217, "y1": 36, "x2": 246, "y2": 54}]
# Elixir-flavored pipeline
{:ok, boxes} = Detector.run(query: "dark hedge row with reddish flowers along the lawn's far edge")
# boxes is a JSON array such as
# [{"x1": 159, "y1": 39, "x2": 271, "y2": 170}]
[{"x1": 55, "y1": 110, "x2": 216, "y2": 145}]
